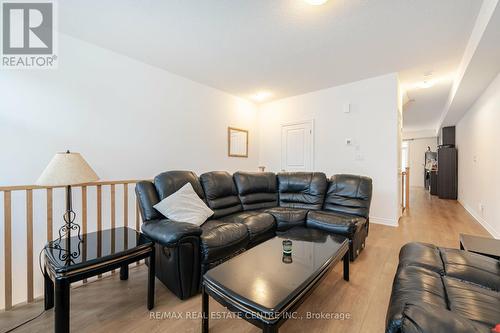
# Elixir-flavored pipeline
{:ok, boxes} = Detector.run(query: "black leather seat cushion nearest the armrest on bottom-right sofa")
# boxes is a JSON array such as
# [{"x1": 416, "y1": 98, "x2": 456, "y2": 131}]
[{"x1": 443, "y1": 277, "x2": 500, "y2": 327}]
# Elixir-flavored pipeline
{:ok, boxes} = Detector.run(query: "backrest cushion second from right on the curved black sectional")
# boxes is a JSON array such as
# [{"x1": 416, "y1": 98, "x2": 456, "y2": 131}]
[{"x1": 278, "y1": 172, "x2": 327, "y2": 209}]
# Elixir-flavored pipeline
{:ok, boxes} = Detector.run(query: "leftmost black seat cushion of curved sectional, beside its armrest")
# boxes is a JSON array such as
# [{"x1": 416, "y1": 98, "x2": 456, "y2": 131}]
[{"x1": 200, "y1": 220, "x2": 249, "y2": 263}]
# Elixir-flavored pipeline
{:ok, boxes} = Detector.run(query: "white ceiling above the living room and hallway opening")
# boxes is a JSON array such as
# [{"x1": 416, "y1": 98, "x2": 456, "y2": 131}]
[{"x1": 59, "y1": 0, "x2": 481, "y2": 127}]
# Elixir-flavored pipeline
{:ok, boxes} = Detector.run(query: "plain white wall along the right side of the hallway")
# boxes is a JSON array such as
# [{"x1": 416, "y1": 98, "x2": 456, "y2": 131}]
[{"x1": 456, "y1": 74, "x2": 500, "y2": 238}]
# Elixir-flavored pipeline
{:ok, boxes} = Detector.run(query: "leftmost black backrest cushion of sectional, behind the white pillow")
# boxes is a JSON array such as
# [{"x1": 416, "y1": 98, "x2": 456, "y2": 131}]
[{"x1": 154, "y1": 171, "x2": 205, "y2": 201}]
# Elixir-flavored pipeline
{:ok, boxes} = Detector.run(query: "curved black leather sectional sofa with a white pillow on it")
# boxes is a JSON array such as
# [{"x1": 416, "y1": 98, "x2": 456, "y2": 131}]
[{"x1": 136, "y1": 171, "x2": 372, "y2": 299}]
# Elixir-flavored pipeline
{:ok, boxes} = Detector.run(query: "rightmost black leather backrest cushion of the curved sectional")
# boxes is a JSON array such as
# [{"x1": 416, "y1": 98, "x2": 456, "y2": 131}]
[{"x1": 323, "y1": 174, "x2": 372, "y2": 218}]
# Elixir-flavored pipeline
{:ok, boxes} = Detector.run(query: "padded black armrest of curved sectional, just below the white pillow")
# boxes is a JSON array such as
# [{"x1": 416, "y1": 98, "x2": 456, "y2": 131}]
[{"x1": 141, "y1": 219, "x2": 201, "y2": 246}]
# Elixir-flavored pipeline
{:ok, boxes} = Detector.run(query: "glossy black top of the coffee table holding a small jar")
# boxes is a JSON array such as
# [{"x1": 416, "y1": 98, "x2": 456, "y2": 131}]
[{"x1": 204, "y1": 227, "x2": 349, "y2": 313}]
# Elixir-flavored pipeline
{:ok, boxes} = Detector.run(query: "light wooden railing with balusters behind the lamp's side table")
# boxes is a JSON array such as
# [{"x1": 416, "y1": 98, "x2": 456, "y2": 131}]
[{"x1": 0, "y1": 179, "x2": 146, "y2": 310}]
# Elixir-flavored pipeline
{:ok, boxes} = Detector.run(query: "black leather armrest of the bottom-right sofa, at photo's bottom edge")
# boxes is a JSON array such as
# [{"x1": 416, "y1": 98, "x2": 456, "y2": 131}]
[{"x1": 386, "y1": 303, "x2": 491, "y2": 333}]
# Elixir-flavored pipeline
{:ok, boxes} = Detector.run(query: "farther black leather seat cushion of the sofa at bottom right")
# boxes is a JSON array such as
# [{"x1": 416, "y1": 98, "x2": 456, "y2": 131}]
[{"x1": 440, "y1": 248, "x2": 500, "y2": 290}]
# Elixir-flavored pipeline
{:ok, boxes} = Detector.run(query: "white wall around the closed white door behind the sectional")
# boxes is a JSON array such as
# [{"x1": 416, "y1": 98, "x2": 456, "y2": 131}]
[{"x1": 259, "y1": 74, "x2": 400, "y2": 225}]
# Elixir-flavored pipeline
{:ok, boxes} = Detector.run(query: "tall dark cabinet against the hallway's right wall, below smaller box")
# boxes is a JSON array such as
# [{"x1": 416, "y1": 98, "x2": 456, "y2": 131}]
[{"x1": 437, "y1": 147, "x2": 458, "y2": 200}]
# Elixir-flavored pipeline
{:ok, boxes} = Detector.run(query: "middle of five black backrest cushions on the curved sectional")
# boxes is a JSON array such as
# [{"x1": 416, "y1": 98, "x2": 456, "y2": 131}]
[{"x1": 233, "y1": 171, "x2": 278, "y2": 210}]
